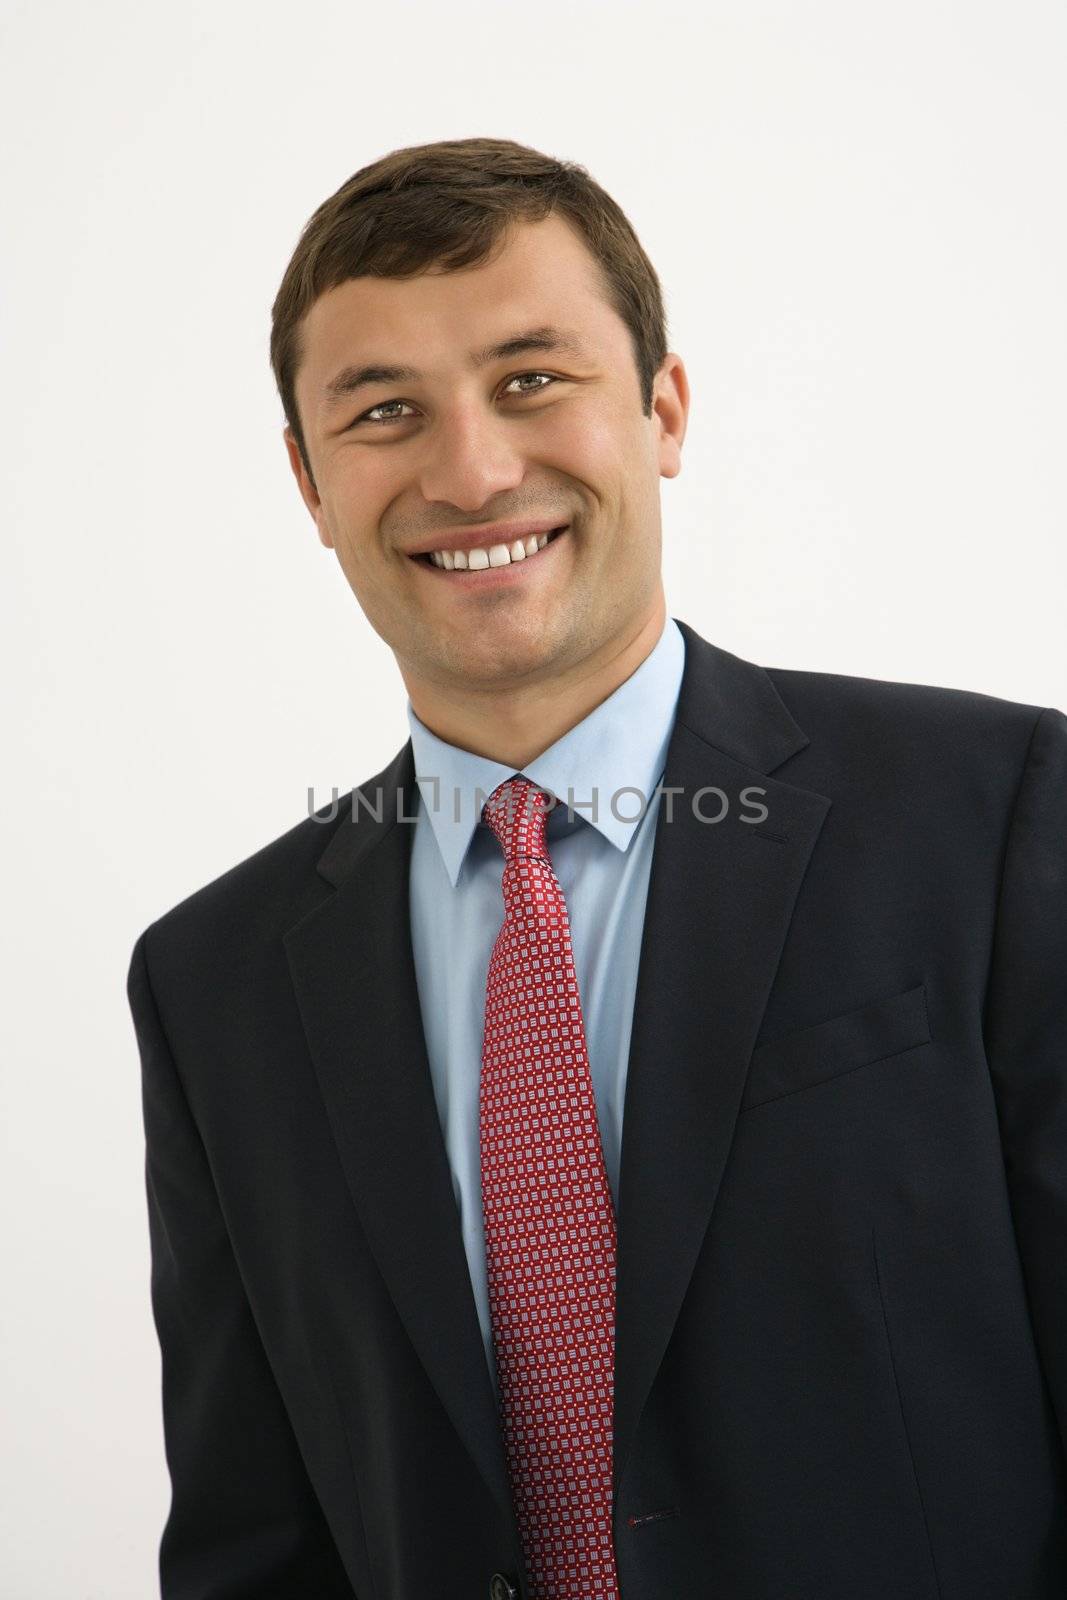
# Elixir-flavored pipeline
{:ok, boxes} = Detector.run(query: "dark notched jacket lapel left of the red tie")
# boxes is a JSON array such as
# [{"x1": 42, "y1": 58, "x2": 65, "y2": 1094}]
[{"x1": 285, "y1": 755, "x2": 518, "y2": 1538}]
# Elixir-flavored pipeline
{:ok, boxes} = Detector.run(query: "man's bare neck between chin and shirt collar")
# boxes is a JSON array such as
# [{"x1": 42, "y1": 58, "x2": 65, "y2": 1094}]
[{"x1": 402, "y1": 587, "x2": 667, "y2": 770}]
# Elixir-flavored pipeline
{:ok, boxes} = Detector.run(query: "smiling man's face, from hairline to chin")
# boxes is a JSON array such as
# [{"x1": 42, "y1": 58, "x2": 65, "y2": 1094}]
[{"x1": 286, "y1": 216, "x2": 688, "y2": 691}]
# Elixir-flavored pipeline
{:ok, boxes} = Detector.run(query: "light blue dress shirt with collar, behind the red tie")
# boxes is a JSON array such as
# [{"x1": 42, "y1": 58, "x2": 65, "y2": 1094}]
[{"x1": 408, "y1": 618, "x2": 685, "y2": 1382}]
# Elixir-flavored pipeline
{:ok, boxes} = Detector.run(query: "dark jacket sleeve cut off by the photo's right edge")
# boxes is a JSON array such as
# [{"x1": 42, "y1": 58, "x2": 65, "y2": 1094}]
[{"x1": 984, "y1": 707, "x2": 1067, "y2": 1448}]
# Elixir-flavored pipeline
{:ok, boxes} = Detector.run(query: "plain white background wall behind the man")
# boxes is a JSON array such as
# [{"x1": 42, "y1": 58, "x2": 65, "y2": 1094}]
[{"x1": 0, "y1": 0, "x2": 1067, "y2": 1600}]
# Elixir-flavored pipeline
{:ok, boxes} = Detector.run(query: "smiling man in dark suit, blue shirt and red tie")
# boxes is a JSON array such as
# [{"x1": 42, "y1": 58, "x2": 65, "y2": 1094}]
[{"x1": 130, "y1": 139, "x2": 1067, "y2": 1600}]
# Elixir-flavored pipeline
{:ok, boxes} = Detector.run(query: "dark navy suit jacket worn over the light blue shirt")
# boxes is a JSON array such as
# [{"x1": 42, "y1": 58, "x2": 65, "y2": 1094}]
[{"x1": 128, "y1": 624, "x2": 1067, "y2": 1600}]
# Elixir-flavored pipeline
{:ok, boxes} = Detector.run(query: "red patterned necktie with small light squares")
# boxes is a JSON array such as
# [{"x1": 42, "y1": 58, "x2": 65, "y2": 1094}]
[{"x1": 480, "y1": 778, "x2": 619, "y2": 1600}]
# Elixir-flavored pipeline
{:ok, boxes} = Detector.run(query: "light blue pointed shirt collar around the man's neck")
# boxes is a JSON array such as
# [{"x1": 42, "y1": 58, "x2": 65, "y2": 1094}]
[{"x1": 408, "y1": 618, "x2": 685, "y2": 888}]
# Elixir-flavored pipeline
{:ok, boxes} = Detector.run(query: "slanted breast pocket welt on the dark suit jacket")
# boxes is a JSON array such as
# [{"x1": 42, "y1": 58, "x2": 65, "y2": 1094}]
[{"x1": 741, "y1": 984, "x2": 931, "y2": 1110}]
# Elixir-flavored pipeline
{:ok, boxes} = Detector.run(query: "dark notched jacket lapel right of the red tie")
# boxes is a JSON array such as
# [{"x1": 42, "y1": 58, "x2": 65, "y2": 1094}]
[{"x1": 614, "y1": 624, "x2": 830, "y2": 1493}]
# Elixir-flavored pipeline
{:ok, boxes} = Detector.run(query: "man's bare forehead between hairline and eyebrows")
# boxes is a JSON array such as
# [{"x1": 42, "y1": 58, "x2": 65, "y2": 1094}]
[{"x1": 296, "y1": 216, "x2": 629, "y2": 416}]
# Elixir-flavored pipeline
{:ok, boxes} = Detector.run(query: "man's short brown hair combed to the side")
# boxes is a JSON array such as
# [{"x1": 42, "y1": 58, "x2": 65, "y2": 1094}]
[{"x1": 270, "y1": 139, "x2": 667, "y2": 477}]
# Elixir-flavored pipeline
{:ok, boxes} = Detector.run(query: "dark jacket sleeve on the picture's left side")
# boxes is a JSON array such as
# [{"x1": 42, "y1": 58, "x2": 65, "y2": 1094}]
[{"x1": 126, "y1": 928, "x2": 354, "y2": 1600}]
